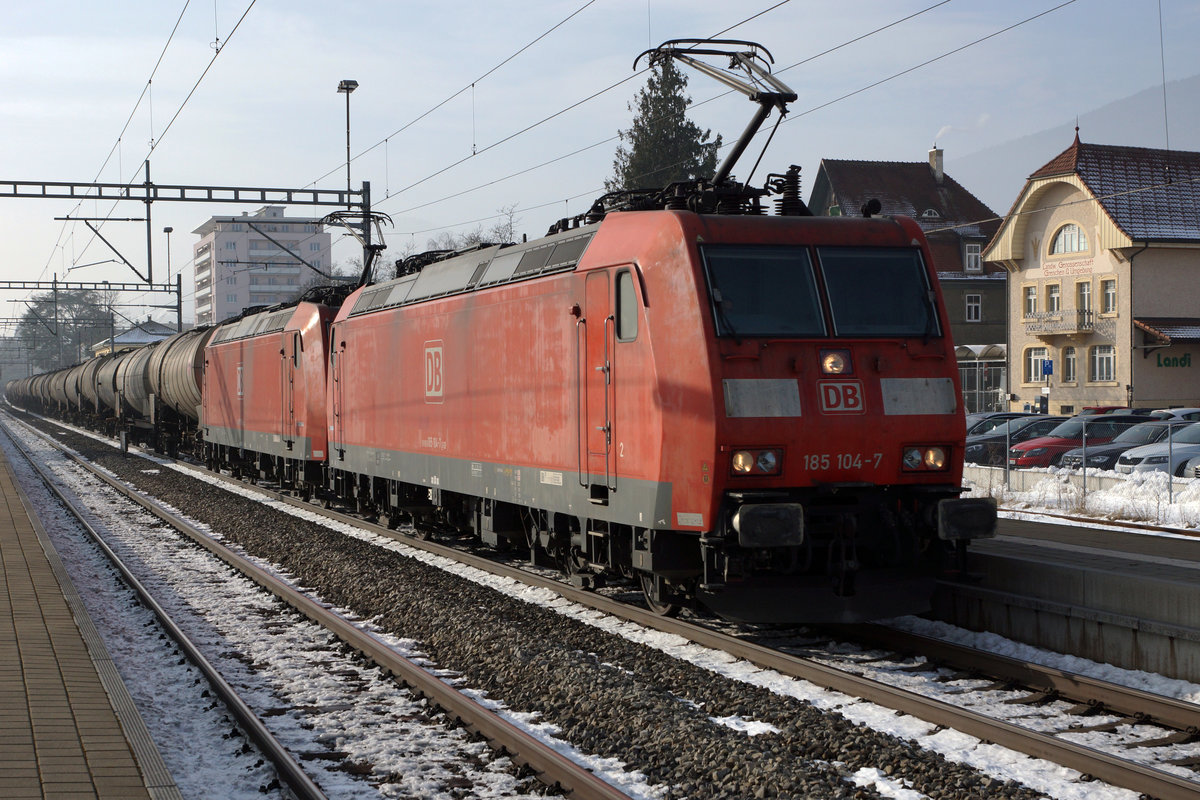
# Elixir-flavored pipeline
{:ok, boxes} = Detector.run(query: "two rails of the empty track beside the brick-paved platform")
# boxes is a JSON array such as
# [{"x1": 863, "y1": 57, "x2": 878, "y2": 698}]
[{"x1": 4, "y1": 417, "x2": 629, "y2": 800}]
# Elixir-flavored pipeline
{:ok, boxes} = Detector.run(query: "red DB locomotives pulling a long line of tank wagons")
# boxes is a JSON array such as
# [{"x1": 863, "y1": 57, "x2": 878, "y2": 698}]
[{"x1": 6, "y1": 40, "x2": 996, "y2": 622}]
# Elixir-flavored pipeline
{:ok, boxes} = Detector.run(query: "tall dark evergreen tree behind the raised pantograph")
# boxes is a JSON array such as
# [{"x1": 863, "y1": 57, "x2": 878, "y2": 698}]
[{"x1": 605, "y1": 59, "x2": 721, "y2": 192}]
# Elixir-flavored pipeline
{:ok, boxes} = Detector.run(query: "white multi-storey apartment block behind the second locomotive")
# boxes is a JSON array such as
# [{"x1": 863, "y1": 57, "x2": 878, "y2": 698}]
[{"x1": 192, "y1": 205, "x2": 332, "y2": 325}]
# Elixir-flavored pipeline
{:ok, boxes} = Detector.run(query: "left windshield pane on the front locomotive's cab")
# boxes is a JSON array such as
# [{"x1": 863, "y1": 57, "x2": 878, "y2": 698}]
[{"x1": 702, "y1": 245, "x2": 826, "y2": 337}]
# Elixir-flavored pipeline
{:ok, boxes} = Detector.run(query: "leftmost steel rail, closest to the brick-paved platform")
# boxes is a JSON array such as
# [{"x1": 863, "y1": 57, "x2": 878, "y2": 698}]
[{"x1": 0, "y1": 426, "x2": 328, "y2": 800}]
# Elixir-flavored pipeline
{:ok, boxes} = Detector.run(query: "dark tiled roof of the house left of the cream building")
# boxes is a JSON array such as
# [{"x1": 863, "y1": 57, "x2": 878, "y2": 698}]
[{"x1": 821, "y1": 158, "x2": 1000, "y2": 239}]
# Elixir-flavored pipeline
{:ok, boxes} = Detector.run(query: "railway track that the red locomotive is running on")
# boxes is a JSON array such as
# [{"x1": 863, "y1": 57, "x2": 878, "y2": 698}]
[{"x1": 14, "y1": 412, "x2": 1200, "y2": 800}]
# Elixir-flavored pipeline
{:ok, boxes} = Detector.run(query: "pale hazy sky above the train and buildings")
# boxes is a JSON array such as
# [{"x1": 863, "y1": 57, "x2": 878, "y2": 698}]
[{"x1": 0, "y1": 0, "x2": 1200, "y2": 331}]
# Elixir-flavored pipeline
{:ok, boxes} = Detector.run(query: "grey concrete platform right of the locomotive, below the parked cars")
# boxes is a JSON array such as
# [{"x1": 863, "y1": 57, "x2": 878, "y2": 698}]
[{"x1": 934, "y1": 519, "x2": 1200, "y2": 682}]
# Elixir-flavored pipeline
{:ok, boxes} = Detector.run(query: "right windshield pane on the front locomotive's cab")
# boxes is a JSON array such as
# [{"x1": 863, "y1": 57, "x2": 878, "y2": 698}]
[{"x1": 817, "y1": 247, "x2": 938, "y2": 337}]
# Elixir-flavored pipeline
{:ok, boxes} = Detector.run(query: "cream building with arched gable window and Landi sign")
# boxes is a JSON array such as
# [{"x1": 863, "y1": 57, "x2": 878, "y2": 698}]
[{"x1": 983, "y1": 131, "x2": 1200, "y2": 414}]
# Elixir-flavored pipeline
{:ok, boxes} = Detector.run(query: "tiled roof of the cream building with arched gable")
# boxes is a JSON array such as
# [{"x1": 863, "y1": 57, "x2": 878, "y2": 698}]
[{"x1": 1030, "y1": 133, "x2": 1200, "y2": 241}]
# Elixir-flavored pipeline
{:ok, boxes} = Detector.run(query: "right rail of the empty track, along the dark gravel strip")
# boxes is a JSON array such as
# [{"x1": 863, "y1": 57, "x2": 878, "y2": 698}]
[{"x1": 9, "y1": 417, "x2": 629, "y2": 800}]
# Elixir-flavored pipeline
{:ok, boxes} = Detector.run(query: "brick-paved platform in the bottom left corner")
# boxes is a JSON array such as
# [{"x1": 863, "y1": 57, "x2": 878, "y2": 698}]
[{"x1": 0, "y1": 441, "x2": 179, "y2": 800}]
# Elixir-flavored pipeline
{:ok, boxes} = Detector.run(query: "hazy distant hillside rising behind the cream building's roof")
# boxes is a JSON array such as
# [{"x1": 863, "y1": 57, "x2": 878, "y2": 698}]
[{"x1": 946, "y1": 74, "x2": 1200, "y2": 213}]
